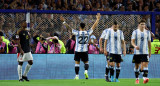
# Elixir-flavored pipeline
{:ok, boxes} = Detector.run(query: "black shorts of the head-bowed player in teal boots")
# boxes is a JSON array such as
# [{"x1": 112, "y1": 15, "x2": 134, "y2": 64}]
[{"x1": 109, "y1": 53, "x2": 122, "y2": 63}]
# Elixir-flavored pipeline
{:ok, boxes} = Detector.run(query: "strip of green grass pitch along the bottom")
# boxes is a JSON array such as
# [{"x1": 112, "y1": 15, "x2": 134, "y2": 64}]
[{"x1": 0, "y1": 78, "x2": 160, "y2": 86}]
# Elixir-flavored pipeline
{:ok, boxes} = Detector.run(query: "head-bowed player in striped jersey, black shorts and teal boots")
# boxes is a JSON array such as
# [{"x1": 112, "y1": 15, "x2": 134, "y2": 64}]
[{"x1": 104, "y1": 21, "x2": 126, "y2": 82}]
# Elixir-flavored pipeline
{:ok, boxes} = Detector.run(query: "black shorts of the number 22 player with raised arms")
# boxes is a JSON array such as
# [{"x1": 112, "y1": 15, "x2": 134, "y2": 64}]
[{"x1": 74, "y1": 52, "x2": 89, "y2": 62}]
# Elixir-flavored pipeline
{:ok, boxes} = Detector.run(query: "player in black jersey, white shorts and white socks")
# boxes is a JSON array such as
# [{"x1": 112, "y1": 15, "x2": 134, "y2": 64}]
[{"x1": 16, "y1": 21, "x2": 33, "y2": 82}]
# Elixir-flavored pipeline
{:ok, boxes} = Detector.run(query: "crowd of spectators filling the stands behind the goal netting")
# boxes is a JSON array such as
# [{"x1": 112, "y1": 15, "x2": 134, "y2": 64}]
[{"x1": 0, "y1": 0, "x2": 160, "y2": 54}]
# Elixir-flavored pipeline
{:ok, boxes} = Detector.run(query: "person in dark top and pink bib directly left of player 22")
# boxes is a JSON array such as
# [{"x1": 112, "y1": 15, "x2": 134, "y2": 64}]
[{"x1": 66, "y1": 35, "x2": 76, "y2": 54}]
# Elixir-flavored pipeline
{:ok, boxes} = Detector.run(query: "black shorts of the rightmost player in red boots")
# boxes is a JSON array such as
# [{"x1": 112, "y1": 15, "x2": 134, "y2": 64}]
[{"x1": 132, "y1": 54, "x2": 149, "y2": 63}]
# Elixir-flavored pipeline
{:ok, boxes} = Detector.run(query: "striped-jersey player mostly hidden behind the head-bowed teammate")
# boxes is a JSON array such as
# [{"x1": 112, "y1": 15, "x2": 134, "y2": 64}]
[{"x1": 99, "y1": 28, "x2": 111, "y2": 82}]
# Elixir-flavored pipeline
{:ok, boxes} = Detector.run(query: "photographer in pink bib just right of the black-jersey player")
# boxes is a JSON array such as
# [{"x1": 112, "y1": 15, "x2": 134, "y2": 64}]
[{"x1": 33, "y1": 35, "x2": 48, "y2": 54}]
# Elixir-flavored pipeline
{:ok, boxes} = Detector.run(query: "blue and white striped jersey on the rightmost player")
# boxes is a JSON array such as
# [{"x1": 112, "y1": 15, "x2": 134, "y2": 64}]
[{"x1": 131, "y1": 29, "x2": 151, "y2": 54}]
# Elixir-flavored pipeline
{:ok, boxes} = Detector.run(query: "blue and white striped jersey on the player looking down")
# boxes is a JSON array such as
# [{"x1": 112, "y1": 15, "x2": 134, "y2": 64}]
[{"x1": 105, "y1": 29, "x2": 124, "y2": 54}]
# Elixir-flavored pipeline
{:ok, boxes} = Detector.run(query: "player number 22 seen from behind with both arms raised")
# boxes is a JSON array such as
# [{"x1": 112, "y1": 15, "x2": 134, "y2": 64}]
[{"x1": 60, "y1": 13, "x2": 101, "y2": 80}]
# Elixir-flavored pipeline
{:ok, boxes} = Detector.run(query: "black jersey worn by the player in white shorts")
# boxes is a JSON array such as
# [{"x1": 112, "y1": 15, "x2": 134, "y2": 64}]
[{"x1": 18, "y1": 30, "x2": 31, "y2": 53}]
